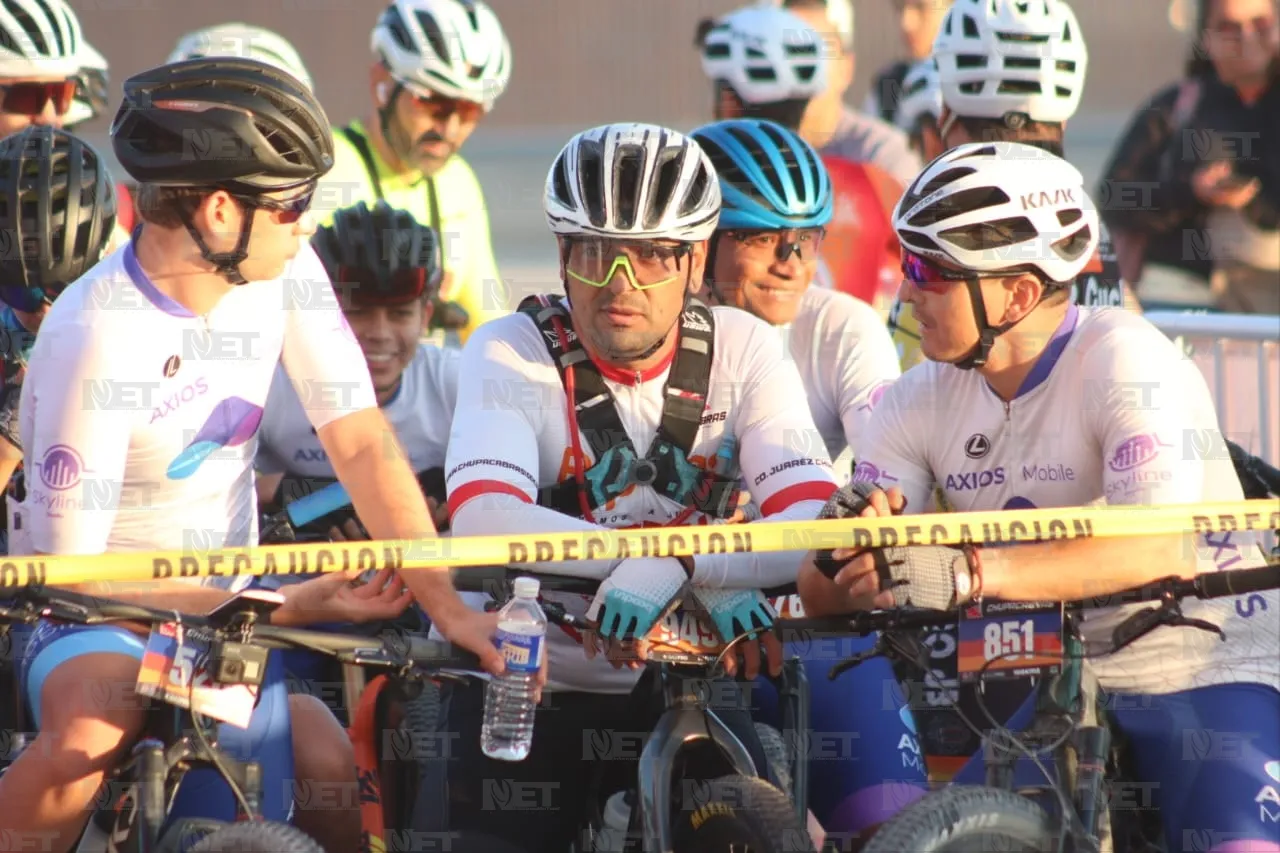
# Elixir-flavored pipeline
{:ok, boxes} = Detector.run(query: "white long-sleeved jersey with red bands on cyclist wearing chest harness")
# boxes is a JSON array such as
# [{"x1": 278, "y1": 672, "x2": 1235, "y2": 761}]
[{"x1": 445, "y1": 307, "x2": 836, "y2": 693}]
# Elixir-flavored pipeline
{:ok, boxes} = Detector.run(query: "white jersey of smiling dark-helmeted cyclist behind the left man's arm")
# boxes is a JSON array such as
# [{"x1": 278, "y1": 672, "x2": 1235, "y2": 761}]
[{"x1": 253, "y1": 343, "x2": 461, "y2": 478}]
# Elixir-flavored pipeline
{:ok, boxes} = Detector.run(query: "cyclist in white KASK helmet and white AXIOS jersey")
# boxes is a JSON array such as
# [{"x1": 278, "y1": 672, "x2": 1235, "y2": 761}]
[{"x1": 800, "y1": 142, "x2": 1280, "y2": 853}]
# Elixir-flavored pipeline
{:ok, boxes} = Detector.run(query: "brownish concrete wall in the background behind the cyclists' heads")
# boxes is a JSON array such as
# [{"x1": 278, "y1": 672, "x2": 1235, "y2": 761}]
[{"x1": 72, "y1": 0, "x2": 1183, "y2": 129}]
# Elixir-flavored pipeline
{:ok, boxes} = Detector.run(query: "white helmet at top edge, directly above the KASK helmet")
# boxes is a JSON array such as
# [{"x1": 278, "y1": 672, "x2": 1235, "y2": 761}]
[{"x1": 933, "y1": 0, "x2": 1089, "y2": 122}]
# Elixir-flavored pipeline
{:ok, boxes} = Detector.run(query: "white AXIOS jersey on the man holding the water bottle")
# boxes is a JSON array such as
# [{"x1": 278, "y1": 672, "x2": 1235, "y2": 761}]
[{"x1": 10, "y1": 239, "x2": 376, "y2": 558}]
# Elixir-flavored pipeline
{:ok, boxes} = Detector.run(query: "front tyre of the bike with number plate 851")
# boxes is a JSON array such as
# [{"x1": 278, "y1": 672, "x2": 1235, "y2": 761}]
[{"x1": 863, "y1": 785, "x2": 1057, "y2": 853}]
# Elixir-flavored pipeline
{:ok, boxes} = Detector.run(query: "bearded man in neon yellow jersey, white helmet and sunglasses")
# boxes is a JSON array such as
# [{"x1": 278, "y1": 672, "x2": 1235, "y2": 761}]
[{"x1": 316, "y1": 0, "x2": 511, "y2": 345}]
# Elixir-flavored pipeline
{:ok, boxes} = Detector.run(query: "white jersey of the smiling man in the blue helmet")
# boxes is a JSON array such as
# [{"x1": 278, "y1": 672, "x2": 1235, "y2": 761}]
[{"x1": 783, "y1": 286, "x2": 901, "y2": 461}]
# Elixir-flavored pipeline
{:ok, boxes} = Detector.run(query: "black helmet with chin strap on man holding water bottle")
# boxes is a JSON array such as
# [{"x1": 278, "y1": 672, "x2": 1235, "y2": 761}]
[{"x1": 111, "y1": 56, "x2": 333, "y2": 284}]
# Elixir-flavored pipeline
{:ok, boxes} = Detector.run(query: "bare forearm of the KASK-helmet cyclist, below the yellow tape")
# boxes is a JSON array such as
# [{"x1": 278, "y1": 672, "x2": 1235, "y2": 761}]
[{"x1": 982, "y1": 535, "x2": 1198, "y2": 601}]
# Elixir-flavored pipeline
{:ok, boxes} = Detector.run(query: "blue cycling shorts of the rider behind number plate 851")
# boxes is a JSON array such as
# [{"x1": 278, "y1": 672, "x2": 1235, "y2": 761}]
[{"x1": 954, "y1": 684, "x2": 1280, "y2": 853}]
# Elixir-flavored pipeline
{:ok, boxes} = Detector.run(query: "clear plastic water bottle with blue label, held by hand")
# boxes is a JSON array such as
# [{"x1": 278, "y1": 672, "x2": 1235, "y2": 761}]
[{"x1": 480, "y1": 578, "x2": 547, "y2": 761}]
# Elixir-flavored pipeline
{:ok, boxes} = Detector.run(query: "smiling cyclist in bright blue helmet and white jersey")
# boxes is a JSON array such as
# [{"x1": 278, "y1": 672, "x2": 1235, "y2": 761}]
[{"x1": 690, "y1": 119, "x2": 928, "y2": 840}]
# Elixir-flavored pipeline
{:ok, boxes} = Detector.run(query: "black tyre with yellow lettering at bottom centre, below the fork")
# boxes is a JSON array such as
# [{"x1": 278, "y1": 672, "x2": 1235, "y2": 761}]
[{"x1": 675, "y1": 776, "x2": 808, "y2": 853}]
